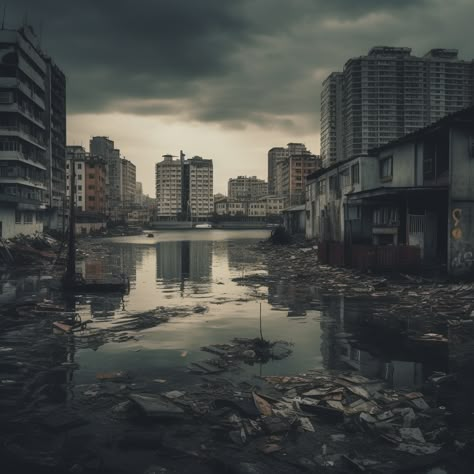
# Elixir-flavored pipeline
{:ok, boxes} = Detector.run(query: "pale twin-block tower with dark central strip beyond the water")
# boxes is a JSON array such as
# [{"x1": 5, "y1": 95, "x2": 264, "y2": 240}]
[{"x1": 155, "y1": 154, "x2": 214, "y2": 220}]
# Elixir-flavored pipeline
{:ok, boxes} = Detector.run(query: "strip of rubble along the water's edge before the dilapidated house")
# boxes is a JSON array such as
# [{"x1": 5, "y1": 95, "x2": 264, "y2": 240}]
[{"x1": 239, "y1": 242, "x2": 474, "y2": 332}]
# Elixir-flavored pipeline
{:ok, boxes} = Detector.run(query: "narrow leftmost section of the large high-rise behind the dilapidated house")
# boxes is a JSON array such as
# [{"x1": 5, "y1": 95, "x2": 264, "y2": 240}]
[{"x1": 320, "y1": 72, "x2": 344, "y2": 167}]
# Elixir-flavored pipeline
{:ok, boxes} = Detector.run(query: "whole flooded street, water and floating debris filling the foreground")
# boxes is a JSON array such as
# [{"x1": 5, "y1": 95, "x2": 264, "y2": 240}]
[{"x1": 0, "y1": 230, "x2": 474, "y2": 474}]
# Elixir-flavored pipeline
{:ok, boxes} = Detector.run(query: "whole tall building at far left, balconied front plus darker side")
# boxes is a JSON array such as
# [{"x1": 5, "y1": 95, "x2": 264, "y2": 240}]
[{"x1": 0, "y1": 26, "x2": 66, "y2": 238}]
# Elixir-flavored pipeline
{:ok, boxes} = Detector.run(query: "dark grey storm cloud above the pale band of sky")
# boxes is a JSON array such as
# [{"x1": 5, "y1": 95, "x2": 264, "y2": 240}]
[{"x1": 7, "y1": 0, "x2": 473, "y2": 128}]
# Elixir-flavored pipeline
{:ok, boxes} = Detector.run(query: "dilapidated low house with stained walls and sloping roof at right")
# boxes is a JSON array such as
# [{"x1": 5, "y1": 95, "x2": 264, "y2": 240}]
[{"x1": 306, "y1": 103, "x2": 474, "y2": 277}]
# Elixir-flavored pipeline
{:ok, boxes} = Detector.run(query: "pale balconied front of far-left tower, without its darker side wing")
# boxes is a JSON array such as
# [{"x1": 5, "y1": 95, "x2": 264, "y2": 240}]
[{"x1": 0, "y1": 27, "x2": 51, "y2": 238}]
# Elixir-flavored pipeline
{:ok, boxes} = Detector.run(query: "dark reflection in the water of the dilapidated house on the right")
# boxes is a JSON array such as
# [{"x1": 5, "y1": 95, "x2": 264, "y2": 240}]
[{"x1": 321, "y1": 296, "x2": 447, "y2": 388}]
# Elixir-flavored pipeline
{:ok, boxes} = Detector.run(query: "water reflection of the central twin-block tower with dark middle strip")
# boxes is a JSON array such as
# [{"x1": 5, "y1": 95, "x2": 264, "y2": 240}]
[{"x1": 156, "y1": 241, "x2": 212, "y2": 282}]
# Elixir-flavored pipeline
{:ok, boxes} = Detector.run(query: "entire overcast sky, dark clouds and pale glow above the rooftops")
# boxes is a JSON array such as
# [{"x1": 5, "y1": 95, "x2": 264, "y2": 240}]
[{"x1": 4, "y1": 0, "x2": 474, "y2": 196}]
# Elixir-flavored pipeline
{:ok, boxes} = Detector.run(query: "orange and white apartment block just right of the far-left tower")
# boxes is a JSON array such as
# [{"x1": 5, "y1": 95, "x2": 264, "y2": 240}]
[{"x1": 66, "y1": 146, "x2": 106, "y2": 214}]
